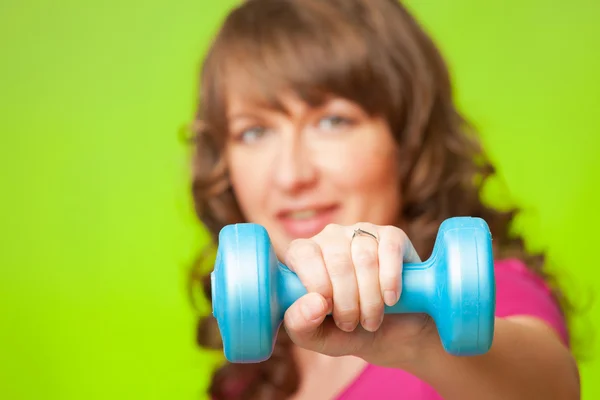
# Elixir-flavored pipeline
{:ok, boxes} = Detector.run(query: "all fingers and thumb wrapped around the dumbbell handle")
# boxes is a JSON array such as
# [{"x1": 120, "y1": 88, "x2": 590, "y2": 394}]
[{"x1": 286, "y1": 223, "x2": 420, "y2": 351}]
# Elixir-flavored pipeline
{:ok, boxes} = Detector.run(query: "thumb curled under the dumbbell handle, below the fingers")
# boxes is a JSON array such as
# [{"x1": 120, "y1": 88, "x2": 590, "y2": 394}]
[{"x1": 284, "y1": 292, "x2": 329, "y2": 351}]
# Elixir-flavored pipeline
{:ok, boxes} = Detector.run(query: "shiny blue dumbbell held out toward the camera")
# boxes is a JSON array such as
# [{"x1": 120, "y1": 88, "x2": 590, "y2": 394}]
[{"x1": 211, "y1": 217, "x2": 496, "y2": 363}]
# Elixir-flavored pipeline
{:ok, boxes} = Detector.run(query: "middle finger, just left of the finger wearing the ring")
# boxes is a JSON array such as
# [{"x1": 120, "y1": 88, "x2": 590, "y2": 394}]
[{"x1": 314, "y1": 225, "x2": 360, "y2": 332}]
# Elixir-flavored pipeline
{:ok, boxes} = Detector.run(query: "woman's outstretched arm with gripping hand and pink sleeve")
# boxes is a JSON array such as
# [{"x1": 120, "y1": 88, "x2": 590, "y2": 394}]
[{"x1": 285, "y1": 224, "x2": 579, "y2": 400}]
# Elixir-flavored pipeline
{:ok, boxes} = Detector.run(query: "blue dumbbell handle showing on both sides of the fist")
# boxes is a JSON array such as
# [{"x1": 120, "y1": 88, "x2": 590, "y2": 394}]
[{"x1": 276, "y1": 259, "x2": 440, "y2": 314}]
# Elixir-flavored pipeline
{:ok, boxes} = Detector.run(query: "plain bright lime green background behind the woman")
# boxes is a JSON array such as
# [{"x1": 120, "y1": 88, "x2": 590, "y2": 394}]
[{"x1": 0, "y1": 0, "x2": 600, "y2": 400}]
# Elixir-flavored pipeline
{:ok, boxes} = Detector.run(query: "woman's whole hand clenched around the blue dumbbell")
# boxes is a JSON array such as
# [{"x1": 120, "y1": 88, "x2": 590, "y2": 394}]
[{"x1": 284, "y1": 223, "x2": 437, "y2": 365}]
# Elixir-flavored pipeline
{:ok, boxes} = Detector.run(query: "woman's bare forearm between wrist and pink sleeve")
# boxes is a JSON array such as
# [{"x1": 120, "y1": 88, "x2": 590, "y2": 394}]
[{"x1": 392, "y1": 316, "x2": 580, "y2": 400}]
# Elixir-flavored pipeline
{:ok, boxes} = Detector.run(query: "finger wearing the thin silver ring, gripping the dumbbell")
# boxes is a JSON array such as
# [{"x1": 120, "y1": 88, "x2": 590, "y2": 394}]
[{"x1": 350, "y1": 224, "x2": 384, "y2": 332}]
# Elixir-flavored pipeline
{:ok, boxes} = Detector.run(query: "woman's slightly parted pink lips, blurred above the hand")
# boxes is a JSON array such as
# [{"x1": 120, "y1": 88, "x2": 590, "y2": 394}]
[{"x1": 277, "y1": 206, "x2": 338, "y2": 238}]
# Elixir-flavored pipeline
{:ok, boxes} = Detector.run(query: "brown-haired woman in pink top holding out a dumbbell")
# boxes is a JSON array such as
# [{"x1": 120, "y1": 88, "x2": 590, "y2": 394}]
[{"x1": 186, "y1": 0, "x2": 579, "y2": 400}]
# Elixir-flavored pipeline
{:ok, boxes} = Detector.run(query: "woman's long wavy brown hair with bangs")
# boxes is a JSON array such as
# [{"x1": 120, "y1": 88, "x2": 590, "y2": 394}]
[{"x1": 185, "y1": 0, "x2": 562, "y2": 400}]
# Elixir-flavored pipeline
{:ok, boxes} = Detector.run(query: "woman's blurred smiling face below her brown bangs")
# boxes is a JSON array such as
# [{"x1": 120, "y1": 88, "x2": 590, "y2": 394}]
[{"x1": 227, "y1": 94, "x2": 400, "y2": 257}]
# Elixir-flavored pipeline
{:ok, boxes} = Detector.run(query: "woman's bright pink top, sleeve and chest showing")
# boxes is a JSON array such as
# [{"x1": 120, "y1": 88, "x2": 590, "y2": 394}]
[{"x1": 337, "y1": 259, "x2": 569, "y2": 400}]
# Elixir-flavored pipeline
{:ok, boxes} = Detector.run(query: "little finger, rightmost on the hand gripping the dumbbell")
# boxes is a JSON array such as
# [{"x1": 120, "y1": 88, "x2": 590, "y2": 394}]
[{"x1": 378, "y1": 226, "x2": 421, "y2": 307}]
